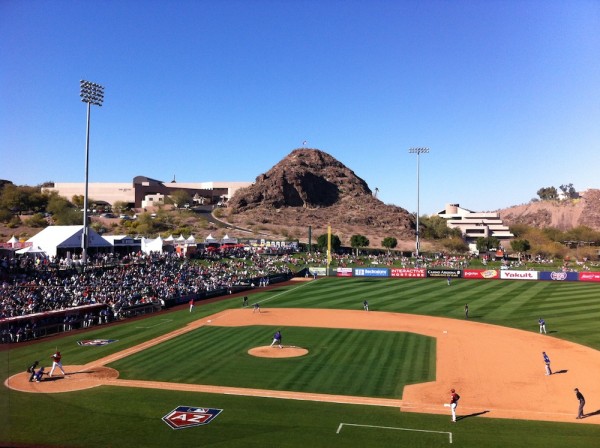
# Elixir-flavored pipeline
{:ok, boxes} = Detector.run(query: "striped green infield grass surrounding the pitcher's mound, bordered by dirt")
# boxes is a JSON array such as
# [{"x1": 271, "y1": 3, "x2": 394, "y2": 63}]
[{"x1": 111, "y1": 326, "x2": 435, "y2": 398}]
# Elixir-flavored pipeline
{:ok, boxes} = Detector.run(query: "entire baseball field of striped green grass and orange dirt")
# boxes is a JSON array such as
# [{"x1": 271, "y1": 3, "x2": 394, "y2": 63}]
[{"x1": 0, "y1": 278, "x2": 600, "y2": 448}]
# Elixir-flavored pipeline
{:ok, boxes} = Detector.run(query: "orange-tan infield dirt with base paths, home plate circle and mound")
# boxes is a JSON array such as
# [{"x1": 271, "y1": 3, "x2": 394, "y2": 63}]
[{"x1": 5, "y1": 308, "x2": 600, "y2": 424}]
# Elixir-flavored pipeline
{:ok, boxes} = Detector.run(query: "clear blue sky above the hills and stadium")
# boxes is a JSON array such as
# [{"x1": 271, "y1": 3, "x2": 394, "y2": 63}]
[{"x1": 0, "y1": 0, "x2": 600, "y2": 214}]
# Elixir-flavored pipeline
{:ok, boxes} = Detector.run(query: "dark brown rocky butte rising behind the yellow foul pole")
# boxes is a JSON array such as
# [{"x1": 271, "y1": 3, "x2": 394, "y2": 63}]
[{"x1": 224, "y1": 148, "x2": 415, "y2": 248}]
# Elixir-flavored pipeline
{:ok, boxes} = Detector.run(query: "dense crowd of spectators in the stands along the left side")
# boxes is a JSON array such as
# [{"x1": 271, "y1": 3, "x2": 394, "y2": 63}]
[{"x1": 0, "y1": 249, "x2": 291, "y2": 342}]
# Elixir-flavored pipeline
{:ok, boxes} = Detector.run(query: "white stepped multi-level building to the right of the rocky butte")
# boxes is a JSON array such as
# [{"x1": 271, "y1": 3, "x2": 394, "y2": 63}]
[{"x1": 438, "y1": 204, "x2": 514, "y2": 252}]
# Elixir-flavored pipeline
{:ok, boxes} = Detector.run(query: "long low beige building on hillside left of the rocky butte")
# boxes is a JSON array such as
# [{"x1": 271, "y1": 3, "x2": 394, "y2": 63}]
[{"x1": 44, "y1": 176, "x2": 251, "y2": 208}]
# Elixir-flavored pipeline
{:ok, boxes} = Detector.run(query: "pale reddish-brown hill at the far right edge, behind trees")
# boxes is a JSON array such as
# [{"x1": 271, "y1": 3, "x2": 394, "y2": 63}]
[{"x1": 498, "y1": 189, "x2": 600, "y2": 231}]
